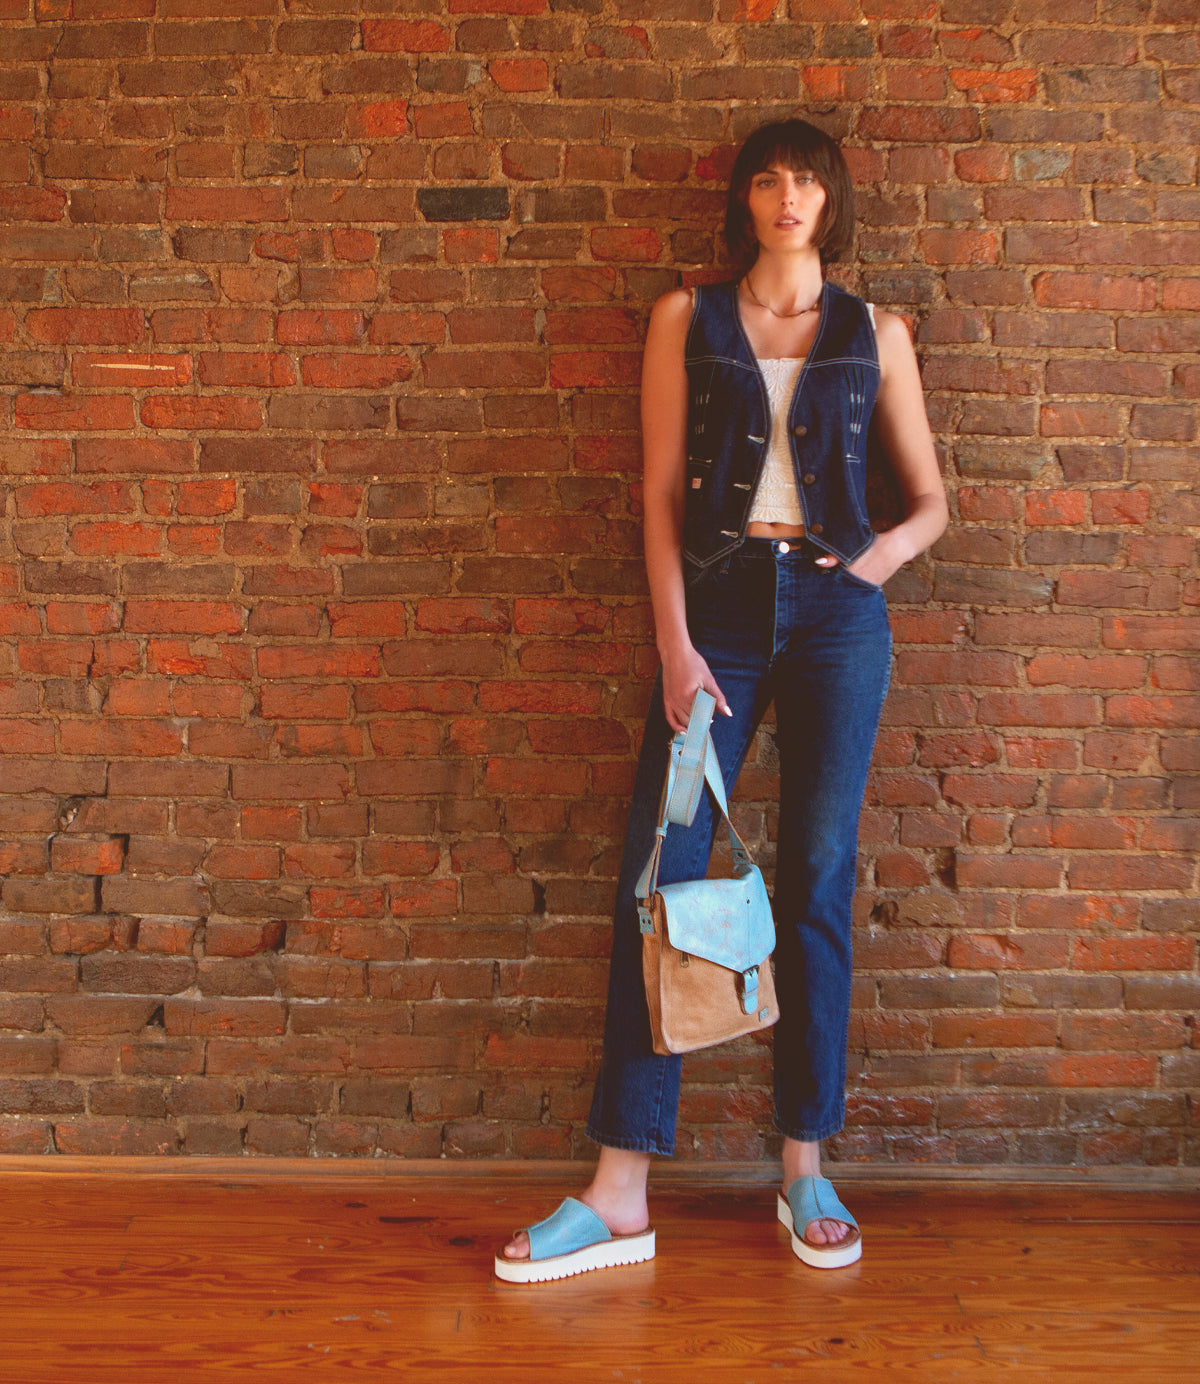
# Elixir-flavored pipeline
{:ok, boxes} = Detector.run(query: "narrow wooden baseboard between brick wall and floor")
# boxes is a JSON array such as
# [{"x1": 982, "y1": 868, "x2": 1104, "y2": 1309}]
[{"x1": 0, "y1": 1154, "x2": 1200, "y2": 1192}]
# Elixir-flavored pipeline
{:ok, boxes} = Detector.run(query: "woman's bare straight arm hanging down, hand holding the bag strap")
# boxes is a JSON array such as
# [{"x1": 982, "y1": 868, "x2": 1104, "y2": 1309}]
[{"x1": 642, "y1": 289, "x2": 729, "y2": 731}]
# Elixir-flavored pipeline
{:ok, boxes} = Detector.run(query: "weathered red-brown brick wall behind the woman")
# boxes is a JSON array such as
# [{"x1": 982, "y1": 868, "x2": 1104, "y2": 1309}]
[{"x1": 0, "y1": 0, "x2": 1200, "y2": 1164}]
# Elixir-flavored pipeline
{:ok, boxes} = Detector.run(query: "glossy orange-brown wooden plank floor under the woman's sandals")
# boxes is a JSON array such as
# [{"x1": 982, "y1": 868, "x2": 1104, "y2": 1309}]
[{"x1": 0, "y1": 1160, "x2": 1200, "y2": 1384}]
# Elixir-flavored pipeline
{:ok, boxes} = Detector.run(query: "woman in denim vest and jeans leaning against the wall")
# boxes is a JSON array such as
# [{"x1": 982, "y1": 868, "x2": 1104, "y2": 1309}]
[{"x1": 496, "y1": 120, "x2": 948, "y2": 1282}]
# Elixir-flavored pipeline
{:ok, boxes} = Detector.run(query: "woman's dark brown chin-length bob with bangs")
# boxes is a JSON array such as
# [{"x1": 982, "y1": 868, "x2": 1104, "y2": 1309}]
[{"x1": 725, "y1": 120, "x2": 854, "y2": 274}]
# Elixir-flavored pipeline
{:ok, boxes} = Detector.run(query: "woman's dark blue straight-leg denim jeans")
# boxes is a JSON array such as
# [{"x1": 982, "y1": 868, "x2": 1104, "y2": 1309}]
[{"x1": 588, "y1": 538, "x2": 891, "y2": 1154}]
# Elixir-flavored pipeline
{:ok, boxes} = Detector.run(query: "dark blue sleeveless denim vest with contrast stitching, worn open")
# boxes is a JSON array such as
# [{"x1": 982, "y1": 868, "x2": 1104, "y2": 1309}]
[{"x1": 684, "y1": 282, "x2": 879, "y2": 584}]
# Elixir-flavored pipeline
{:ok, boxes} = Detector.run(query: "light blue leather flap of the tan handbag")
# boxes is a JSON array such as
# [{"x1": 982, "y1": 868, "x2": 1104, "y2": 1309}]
[{"x1": 659, "y1": 865, "x2": 775, "y2": 972}]
